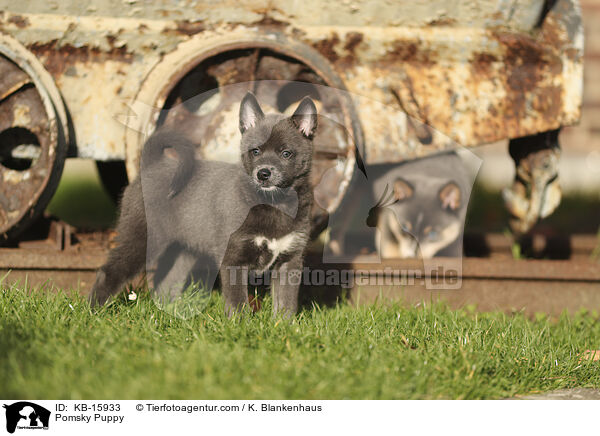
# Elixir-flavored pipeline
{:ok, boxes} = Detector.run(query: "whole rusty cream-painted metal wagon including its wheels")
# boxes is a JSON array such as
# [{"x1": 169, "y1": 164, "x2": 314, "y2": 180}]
[{"x1": 0, "y1": 0, "x2": 583, "y2": 241}]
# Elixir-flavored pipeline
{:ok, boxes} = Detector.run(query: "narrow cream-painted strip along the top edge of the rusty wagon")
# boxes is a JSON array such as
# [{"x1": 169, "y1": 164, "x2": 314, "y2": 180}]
[{"x1": 0, "y1": 0, "x2": 544, "y2": 33}]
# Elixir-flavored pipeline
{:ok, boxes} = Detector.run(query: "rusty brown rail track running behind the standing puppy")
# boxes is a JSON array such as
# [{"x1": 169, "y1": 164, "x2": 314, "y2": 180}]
[{"x1": 0, "y1": 221, "x2": 600, "y2": 315}]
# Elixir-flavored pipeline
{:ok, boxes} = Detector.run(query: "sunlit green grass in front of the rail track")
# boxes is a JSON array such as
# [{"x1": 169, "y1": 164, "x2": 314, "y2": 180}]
[{"x1": 0, "y1": 283, "x2": 600, "y2": 399}]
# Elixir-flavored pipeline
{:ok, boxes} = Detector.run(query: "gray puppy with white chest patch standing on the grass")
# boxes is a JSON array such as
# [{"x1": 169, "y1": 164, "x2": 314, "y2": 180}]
[{"x1": 90, "y1": 93, "x2": 317, "y2": 315}]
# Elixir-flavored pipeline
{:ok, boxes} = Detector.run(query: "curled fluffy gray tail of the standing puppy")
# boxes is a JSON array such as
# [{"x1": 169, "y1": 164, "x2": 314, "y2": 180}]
[{"x1": 141, "y1": 130, "x2": 196, "y2": 198}]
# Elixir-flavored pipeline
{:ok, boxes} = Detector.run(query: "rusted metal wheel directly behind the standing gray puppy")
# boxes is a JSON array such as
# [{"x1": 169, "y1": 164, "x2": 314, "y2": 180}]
[{"x1": 127, "y1": 38, "x2": 363, "y2": 233}]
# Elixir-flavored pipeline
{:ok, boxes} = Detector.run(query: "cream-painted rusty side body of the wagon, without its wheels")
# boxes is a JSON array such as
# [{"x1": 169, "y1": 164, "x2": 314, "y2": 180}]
[{"x1": 0, "y1": 0, "x2": 583, "y2": 163}]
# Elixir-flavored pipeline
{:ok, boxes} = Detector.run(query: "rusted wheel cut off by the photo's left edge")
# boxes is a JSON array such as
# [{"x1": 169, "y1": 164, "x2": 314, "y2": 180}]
[{"x1": 0, "y1": 36, "x2": 67, "y2": 244}]
